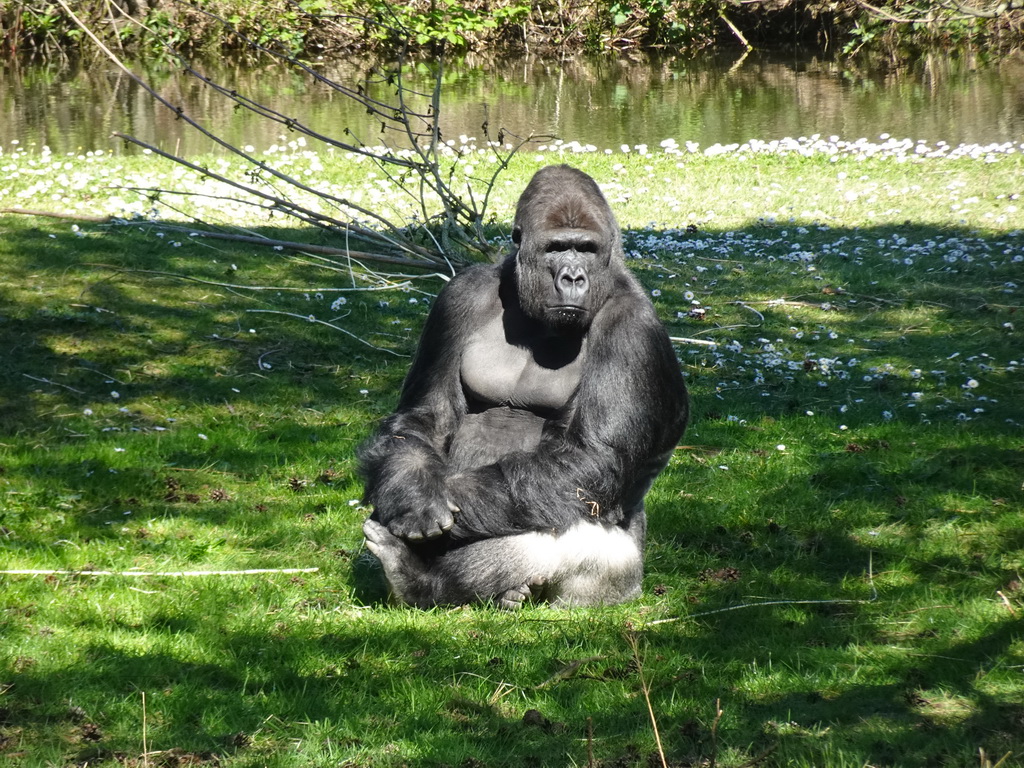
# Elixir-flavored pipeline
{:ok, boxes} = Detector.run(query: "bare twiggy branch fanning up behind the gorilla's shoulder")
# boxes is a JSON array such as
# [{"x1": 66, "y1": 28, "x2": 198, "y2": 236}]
[{"x1": 51, "y1": 0, "x2": 524, "y2": 271}]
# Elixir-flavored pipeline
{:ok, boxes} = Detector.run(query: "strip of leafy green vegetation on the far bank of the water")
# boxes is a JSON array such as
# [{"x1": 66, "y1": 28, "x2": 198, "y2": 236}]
[{"x1": 0, "y1": 0, "x2": 1024, "y2": 58}]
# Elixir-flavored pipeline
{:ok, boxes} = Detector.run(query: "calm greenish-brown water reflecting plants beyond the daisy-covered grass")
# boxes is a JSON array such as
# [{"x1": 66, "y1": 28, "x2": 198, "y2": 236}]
[{"x1": 0, "y1": 52, "x2": 1024, "y2": 155}]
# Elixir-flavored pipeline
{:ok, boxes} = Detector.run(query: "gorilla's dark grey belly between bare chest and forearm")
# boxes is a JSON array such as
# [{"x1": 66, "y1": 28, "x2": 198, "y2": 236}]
[{"x1": 449, "y1": 407, "x2": 544, "y2": 472}]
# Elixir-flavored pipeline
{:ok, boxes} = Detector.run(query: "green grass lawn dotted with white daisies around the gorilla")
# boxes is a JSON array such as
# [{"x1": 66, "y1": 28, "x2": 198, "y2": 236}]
[{"x1": 0, "y1": 141, "x2": 1024, "y2": 768}]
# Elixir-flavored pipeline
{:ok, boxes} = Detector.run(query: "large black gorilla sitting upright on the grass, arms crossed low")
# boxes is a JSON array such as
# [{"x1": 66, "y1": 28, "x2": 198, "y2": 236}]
[{"x1": 359, "y1": 166, "x2": 687, "y2": 607}]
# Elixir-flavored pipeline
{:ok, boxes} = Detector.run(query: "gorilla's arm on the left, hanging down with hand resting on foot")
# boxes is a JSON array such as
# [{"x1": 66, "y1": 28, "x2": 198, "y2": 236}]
[{"x1": 359, "y1": 268, "x2": 497, "y2": 540}]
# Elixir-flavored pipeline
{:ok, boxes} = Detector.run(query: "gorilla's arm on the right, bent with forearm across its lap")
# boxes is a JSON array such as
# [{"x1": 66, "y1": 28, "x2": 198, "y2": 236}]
[{"x1": 447, "y1": 276, "x2": 686, "y2": 542}]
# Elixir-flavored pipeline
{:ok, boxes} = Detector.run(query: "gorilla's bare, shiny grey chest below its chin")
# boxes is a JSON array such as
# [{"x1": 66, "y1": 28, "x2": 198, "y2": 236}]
[{"x1": 461, "y1": 316, "x2": 586, "y2": 414}]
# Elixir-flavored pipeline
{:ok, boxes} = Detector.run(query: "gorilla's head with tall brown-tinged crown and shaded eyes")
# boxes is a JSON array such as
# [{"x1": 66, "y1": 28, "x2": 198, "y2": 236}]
[{"x1": 512, "y1": 165, "x2": 624, "y2": 333}]
